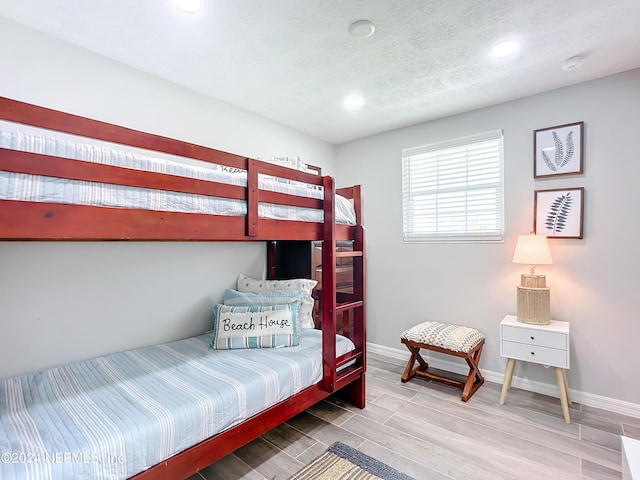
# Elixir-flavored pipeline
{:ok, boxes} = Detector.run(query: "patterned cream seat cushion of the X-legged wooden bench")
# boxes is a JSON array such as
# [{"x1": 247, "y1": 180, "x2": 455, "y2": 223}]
[{"x1": 400, "y1": 322, "x2": 485, "y2": 353}]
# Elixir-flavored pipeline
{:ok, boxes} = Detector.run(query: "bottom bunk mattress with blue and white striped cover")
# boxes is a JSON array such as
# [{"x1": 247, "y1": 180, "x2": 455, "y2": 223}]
[{"x1": 0, "y1": 329, "x2": 354, "y2": 480}]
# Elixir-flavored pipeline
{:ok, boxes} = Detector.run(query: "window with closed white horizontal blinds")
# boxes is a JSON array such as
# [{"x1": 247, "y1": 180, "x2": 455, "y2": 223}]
[{"x1": 402, "y1": 130, "x2": 504, "y2": 242}]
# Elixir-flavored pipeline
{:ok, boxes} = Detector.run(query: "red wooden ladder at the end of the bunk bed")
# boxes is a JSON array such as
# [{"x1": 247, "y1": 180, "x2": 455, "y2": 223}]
[{"x1": 321, "y1": 177, "x2": 366, "y2": 398}]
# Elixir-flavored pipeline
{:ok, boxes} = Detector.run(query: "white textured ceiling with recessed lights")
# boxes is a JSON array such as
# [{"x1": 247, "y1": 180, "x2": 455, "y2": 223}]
[{"x1": 0, "y1": 0, "x2": 640, "y2": 144}]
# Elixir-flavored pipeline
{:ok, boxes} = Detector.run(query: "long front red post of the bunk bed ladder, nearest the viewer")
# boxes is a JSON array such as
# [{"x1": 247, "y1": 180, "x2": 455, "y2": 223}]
[{"x1": 321, "y1": 176, "x2": 337, "y2": 392}]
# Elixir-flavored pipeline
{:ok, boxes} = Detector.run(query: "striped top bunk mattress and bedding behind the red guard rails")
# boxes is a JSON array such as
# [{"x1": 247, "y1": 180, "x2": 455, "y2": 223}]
[{"x1": 0, "y1": 129, "x2": 356, "y2": 225}]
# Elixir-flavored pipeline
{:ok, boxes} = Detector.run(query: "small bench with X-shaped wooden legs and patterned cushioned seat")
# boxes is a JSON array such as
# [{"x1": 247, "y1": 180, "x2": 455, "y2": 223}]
[{"x1": 400, "y1": 322, "x2": 485, "y2": 402}]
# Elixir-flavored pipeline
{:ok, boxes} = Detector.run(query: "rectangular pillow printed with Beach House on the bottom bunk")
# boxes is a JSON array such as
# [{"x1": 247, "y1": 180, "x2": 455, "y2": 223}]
[{"x1": 209, "y1": 301, "x2": 300, "y2": 350}]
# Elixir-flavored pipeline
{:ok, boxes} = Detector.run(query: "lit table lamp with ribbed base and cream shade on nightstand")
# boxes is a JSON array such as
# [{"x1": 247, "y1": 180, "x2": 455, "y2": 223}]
[{"x1": 513, "y1": 233, "x2": 553, "y2": 325}]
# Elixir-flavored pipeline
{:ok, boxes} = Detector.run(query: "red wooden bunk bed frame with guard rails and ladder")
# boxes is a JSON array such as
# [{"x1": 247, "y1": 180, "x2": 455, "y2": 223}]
[{"x1": 0, "y1": 98, "x2": 366, "y2": 480}]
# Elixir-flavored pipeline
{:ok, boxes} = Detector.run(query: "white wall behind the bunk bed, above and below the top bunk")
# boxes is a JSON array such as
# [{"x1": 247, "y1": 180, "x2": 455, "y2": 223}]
[{"x1": 0, "y1": 18, "x2": 335, "y2": 378}]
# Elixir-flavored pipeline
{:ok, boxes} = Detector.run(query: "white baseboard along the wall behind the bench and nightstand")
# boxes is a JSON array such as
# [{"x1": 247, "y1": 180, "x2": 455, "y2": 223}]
[{"x1": 367, "y1": 343, "x2": 640, "y2": 418}]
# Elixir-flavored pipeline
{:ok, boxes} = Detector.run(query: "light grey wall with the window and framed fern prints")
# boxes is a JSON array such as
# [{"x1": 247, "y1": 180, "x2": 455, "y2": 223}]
[{"x1": 338, "y1": 70, "x2": 640, "y2": 411}]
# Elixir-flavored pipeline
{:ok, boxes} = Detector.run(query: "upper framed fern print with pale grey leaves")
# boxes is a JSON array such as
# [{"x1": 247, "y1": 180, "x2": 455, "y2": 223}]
[{"x1": 533, "y1": 122, "x2": 584, "y2": 178}]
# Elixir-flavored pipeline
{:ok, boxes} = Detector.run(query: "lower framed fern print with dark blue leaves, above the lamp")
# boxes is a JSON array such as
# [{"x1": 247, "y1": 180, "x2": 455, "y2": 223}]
[{"x1": 533, "y1": 187, "x2": 584, "y2": 238}]
